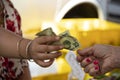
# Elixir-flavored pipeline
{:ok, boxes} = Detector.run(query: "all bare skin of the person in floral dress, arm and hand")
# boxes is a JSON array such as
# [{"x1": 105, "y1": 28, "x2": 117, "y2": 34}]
[{"x1": 0, "y1": 0, "x2": 63, "y2": 80}]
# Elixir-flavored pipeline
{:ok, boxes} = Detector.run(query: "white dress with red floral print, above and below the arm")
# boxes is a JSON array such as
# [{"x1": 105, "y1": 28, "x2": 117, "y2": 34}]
[{"x1": 0, "y1": 0, "x2": 28, "y2": 80}]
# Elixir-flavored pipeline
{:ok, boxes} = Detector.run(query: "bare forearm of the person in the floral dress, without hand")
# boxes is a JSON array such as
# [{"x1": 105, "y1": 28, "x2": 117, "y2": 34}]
[{"x1": 0, "y1": 27, "x2": 30, "y2": 58}]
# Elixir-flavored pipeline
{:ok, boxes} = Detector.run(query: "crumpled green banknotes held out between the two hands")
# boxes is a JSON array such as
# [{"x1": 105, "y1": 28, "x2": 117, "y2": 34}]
[{"x1": 36, "y1": 28, "x2": 80, "y2": 51}]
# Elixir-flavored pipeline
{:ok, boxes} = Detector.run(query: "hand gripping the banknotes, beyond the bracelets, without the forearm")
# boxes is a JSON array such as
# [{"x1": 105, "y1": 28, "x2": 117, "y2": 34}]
[{"x1": 29, "y1": 36, "x2": 63, "y2": 67}]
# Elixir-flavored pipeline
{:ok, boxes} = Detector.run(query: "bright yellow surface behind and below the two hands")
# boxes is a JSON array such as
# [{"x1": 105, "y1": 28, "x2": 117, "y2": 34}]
[{"x1": 23, "y1": 18, "x2": 120, "y2": 80}]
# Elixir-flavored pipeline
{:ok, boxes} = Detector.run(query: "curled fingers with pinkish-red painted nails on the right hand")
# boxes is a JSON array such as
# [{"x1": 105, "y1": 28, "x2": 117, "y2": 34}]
[{"x1": 79, "y1": 56, "x2": 100, "y2": 76}]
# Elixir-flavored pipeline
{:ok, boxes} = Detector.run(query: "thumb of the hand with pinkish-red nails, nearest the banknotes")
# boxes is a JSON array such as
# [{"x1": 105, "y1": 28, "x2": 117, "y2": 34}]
[{"x1": 77, "y1": 47, "x2": 93, "y2": 56}]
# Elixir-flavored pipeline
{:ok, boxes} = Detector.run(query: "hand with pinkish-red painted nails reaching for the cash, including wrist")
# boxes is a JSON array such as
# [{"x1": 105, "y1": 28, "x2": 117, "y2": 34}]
[{"x1": 77, "y1": 44, "x2": 120, "y2": 76}]
